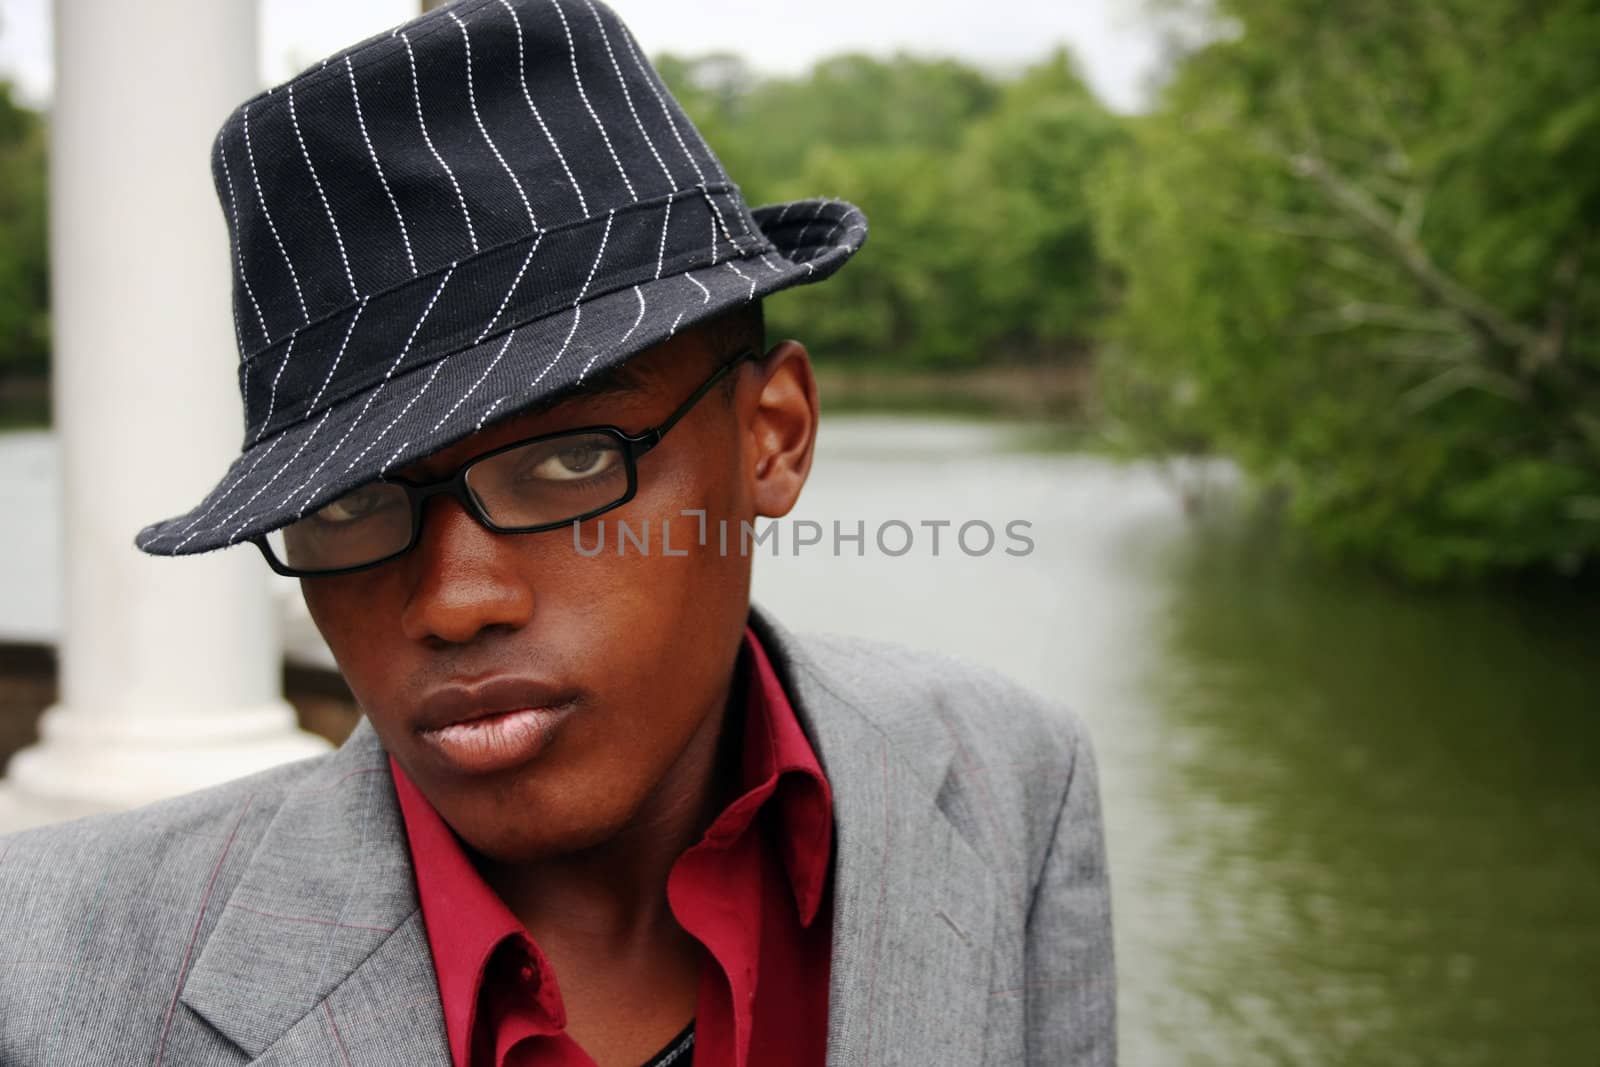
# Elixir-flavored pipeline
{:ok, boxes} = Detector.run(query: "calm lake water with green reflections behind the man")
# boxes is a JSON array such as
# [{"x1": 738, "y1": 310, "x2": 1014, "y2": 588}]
[{"x1": 0, "y1": 418, "x2": 1600, "y2": 1067}]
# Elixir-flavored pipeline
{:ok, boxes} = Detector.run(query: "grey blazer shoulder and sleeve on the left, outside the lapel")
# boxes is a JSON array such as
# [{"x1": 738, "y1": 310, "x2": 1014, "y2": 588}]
[{"x1": 0, "y1": 755, "x2": 340, "y2": 1064}]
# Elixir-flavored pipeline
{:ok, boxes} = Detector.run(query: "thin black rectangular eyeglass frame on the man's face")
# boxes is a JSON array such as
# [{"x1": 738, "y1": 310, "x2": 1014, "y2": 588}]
[{"x1": 251, "y1": 349, "x2": 758, "y2": 577}]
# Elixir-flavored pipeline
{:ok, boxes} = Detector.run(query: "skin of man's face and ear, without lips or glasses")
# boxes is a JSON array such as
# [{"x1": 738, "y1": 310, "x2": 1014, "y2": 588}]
[{"x1": 302, "y1": 333, "x2": 816, "y2": 862}]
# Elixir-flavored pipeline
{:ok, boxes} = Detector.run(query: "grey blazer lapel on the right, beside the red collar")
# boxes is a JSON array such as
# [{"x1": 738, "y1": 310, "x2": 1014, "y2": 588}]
[{"x1": 752, "y1": 608, "x2": 997, "y2": 1067}]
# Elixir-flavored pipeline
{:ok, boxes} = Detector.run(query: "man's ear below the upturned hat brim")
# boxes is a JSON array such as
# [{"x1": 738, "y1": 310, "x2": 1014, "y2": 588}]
[{"x1": 741, "y1": 341, "x2": 818, "y2": 518}]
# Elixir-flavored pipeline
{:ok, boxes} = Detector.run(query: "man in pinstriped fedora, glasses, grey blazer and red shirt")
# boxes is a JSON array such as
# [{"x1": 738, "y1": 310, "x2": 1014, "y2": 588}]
[{"x1": 0, "y1": 0, "x2": 1114, "y2": 1067}]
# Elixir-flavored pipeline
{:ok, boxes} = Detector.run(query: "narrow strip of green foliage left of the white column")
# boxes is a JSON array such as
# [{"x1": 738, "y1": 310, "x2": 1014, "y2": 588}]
[{"x1": 0, "y1": 82, "x2": 50, "y2": 390}]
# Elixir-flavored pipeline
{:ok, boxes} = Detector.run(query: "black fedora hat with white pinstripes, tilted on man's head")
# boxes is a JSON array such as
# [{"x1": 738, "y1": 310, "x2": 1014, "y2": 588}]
[{"x1": 138, "y1": 0, "x2": 867, "y2": 555}]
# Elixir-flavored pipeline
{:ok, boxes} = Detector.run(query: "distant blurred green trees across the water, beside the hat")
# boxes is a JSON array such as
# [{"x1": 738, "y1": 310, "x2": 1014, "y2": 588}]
[{"x1": 658, "y1": 51, "x2": 1123, "y2": 370}]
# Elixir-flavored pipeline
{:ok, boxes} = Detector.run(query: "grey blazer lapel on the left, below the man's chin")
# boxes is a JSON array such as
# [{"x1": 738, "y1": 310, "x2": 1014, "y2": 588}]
[{"x1": 181, "y1": 718, "x2": 450, "y2": 1067}]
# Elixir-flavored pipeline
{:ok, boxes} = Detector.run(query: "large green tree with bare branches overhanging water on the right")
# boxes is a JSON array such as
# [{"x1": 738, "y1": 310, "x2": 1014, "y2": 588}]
[{"x1": 1093, "y1": 0, "x2": 1600, "y2": 581}]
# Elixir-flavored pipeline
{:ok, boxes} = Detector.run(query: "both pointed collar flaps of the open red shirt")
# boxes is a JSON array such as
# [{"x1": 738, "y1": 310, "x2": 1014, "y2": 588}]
[{"x1": 389, "y1": 627, "x2": 834, "y2": 1064}]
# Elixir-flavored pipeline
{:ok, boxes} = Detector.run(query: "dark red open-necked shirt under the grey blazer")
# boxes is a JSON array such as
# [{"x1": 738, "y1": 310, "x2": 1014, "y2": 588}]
[{"x1": 389, "y1": 629, "x2": 834, "y2": 1067}]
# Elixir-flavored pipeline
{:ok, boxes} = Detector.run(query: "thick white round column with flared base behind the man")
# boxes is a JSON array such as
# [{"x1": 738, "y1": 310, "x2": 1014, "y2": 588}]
[{"x1": 0, "y1": 0, "x2": 328, "y2": 827}]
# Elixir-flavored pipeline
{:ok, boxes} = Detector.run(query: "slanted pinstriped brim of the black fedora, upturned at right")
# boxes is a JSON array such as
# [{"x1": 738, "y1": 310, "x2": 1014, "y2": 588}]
[{"x1": 136, "y1": 200, "x2": 867, "y2": 555}]
